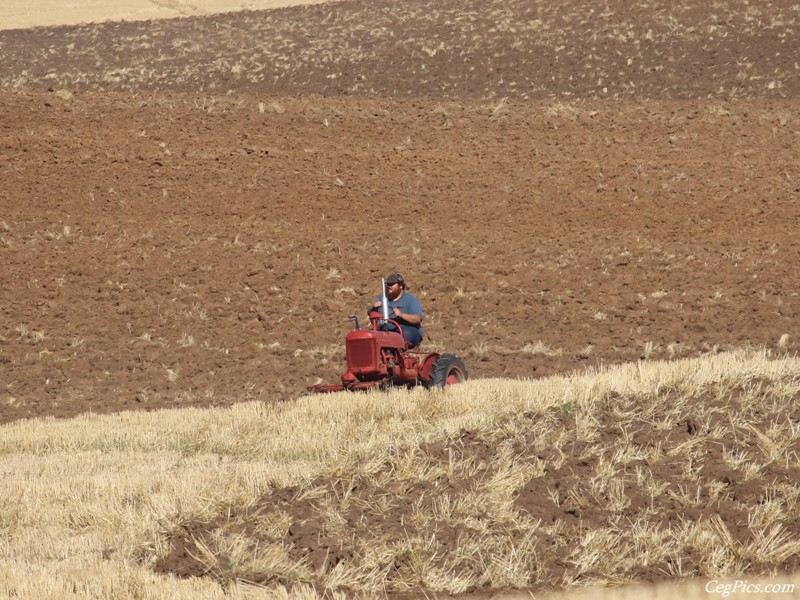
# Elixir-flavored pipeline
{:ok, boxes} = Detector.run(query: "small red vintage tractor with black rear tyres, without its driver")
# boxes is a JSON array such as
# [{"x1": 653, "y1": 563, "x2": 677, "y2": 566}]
[{"x1": 308, "y1": 304, "x2": 468, "y2": 393}]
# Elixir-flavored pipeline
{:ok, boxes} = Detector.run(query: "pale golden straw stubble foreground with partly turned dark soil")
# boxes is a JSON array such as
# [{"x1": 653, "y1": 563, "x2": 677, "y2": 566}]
[{"x1": 0, "y1": 353, "x2": 800, "y2": 598}]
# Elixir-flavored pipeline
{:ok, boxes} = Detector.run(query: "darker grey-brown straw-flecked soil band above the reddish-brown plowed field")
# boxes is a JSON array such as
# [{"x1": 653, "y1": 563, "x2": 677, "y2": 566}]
[{"x1": 0, "y1": 0, "x2": 800, "y2": 100}]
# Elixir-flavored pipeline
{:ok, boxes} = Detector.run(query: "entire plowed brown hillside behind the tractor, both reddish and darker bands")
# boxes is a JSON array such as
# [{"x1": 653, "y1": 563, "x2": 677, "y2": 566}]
[{"x1": 0, "y1": 1, "x2": 800, "y2": 422}]
